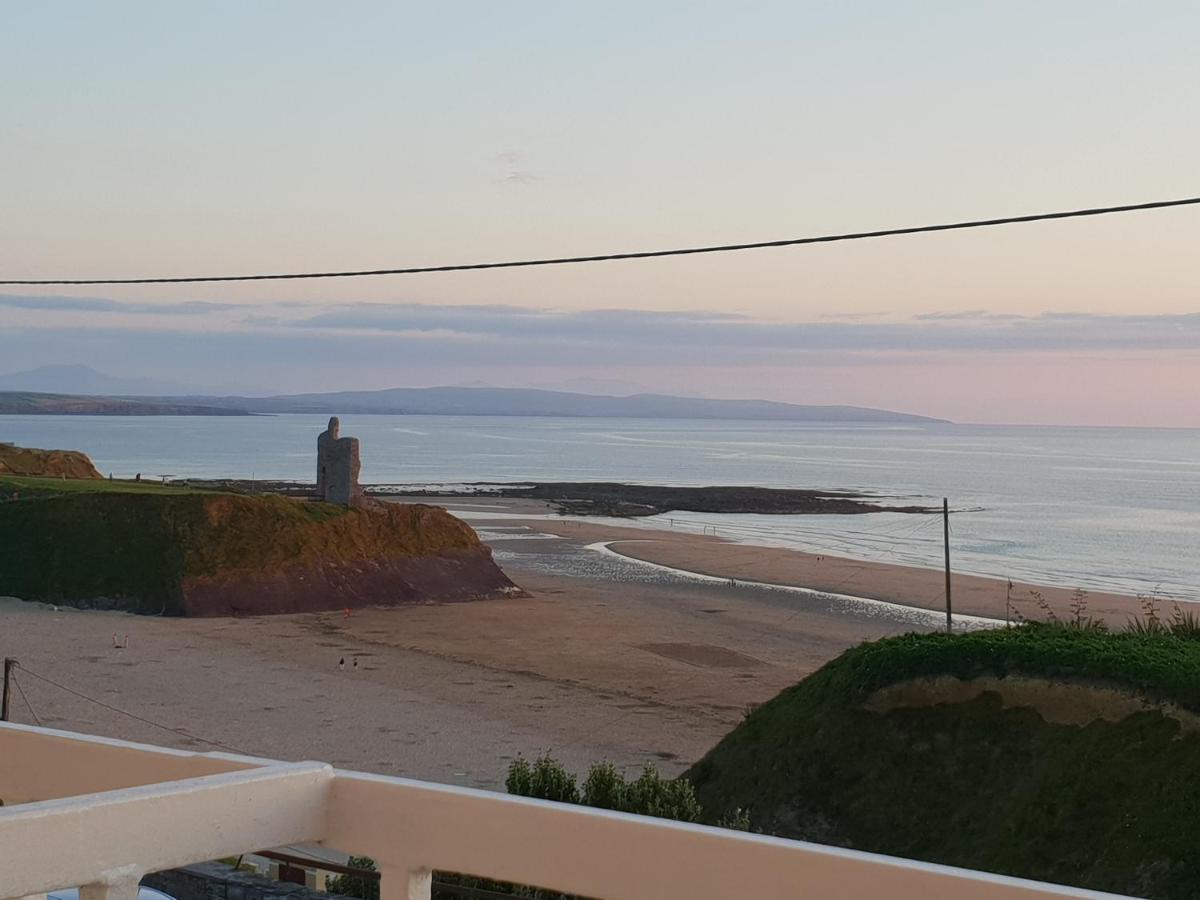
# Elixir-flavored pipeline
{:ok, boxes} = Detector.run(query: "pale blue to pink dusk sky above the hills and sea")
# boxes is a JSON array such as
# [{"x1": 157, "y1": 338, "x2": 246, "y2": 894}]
[{"x1": 0, "y1": 0, "x2": 1200, "y2": 427}]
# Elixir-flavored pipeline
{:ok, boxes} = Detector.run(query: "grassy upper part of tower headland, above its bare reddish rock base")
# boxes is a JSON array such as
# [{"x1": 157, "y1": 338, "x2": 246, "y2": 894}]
[{"x1": 0, "y1": 489, "x2": 482, "y2": 613}]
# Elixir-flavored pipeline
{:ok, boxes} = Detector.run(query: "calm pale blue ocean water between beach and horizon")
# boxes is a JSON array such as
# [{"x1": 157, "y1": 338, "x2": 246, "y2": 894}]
[{"x1": 7, "y1": 415, "x2": 1200, "y2": 600}]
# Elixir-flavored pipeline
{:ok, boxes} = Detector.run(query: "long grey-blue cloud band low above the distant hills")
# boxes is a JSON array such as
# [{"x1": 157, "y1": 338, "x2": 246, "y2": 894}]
[{"x1": 7, "y1": 295, "x2": 1200, "y2": 367}]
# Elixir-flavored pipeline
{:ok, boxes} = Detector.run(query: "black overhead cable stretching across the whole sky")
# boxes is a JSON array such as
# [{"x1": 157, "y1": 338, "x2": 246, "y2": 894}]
[{"x1": 0, "y1": 197, "x2": 1200, "y2": 284}]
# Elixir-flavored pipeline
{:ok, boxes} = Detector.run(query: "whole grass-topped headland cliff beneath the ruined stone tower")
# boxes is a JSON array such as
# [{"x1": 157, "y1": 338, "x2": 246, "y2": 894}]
[{"x1": 0, "y1": 482, "x2": 515, "y2": 616}]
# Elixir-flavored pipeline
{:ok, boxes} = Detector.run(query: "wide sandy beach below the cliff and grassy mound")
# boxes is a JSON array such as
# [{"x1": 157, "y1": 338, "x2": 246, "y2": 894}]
[{"x1": 0, "y1": 498, "x2": 1161, "y2": 787}]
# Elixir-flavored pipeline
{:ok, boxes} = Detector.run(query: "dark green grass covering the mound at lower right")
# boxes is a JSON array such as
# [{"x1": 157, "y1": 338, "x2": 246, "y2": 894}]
[{"x1": 686, "y1": 625, "x2": 1200, "y2": 898}]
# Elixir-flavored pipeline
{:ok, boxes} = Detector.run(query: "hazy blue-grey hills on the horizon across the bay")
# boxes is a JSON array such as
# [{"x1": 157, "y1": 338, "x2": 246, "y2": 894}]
[{"x1": 0, "y1": 388, "x2": 943, "y2": 424}]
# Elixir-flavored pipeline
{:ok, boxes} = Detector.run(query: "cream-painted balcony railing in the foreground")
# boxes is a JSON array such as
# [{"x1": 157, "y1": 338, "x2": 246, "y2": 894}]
[{"x1": 0, "y1": 724, "x2": 1112, "y2": 900}]
